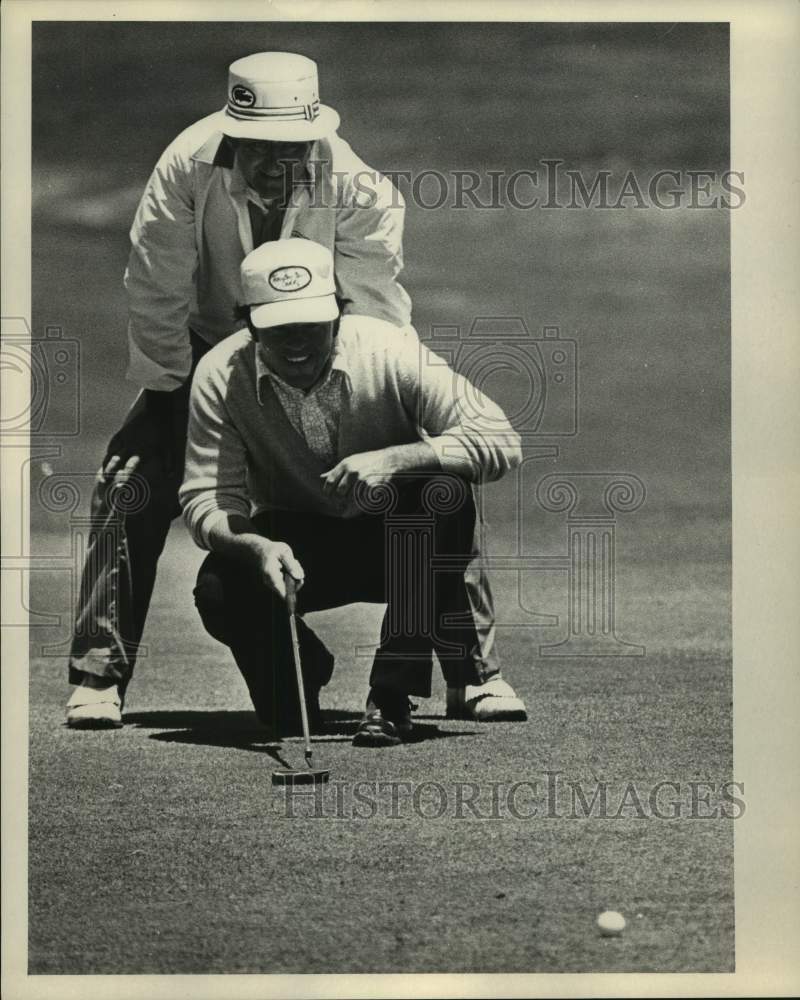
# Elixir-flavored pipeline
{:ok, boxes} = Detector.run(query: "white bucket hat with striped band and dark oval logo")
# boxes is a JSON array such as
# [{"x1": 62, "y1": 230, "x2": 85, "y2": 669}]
[{"x1": 220, "y1": 52, "x2": 339, "y2": 142}]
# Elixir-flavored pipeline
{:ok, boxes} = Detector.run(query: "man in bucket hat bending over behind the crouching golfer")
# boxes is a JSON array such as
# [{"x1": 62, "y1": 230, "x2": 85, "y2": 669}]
[{"x1": 67, "y1": 52, "x2": 410, "y2": 728}]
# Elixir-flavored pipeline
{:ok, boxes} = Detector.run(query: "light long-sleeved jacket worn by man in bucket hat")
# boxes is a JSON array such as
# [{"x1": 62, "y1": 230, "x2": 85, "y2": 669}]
[{"x1": 125, "y1": 114, "x2": 411, "y2": 391}]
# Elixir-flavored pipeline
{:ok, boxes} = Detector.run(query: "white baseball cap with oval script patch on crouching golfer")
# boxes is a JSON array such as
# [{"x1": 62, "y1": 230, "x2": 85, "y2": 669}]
[{"x1": 241, "y1": 237, "x2": 339, "y2": 330}]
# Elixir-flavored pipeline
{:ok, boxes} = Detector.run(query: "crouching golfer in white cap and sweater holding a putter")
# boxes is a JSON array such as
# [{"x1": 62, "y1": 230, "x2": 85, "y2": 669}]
[{"x1": 180, "y1": 239, "x2": 526, "y2": 746}]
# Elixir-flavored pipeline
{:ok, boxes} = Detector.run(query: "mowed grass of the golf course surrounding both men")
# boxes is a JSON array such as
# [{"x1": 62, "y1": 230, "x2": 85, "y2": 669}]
[{"x1": 29, "y1": 24, "x2": 734, "y2": 974}]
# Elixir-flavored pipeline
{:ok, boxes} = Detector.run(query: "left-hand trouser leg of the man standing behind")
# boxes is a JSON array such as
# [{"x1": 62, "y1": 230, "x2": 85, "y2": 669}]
[{"x1": 69, "y1": 334, "x2": 210, "y2": 693}]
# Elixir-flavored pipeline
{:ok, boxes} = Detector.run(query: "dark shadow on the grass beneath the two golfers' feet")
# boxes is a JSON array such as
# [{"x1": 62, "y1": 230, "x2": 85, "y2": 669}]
[{"x1": 124, "y1": 709, "x2": 475, "y2": 763}]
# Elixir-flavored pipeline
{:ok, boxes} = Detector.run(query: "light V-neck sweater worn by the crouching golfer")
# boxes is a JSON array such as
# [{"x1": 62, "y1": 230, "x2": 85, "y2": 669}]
[{"x1": 180, "y1": 315, "x2": 521, "y2": 547}]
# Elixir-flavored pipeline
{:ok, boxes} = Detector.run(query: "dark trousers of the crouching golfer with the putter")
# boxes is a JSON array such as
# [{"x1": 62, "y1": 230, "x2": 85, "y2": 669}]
[{"x1": 195, "y1": 475, "x2": 499, "y2": 725}]
